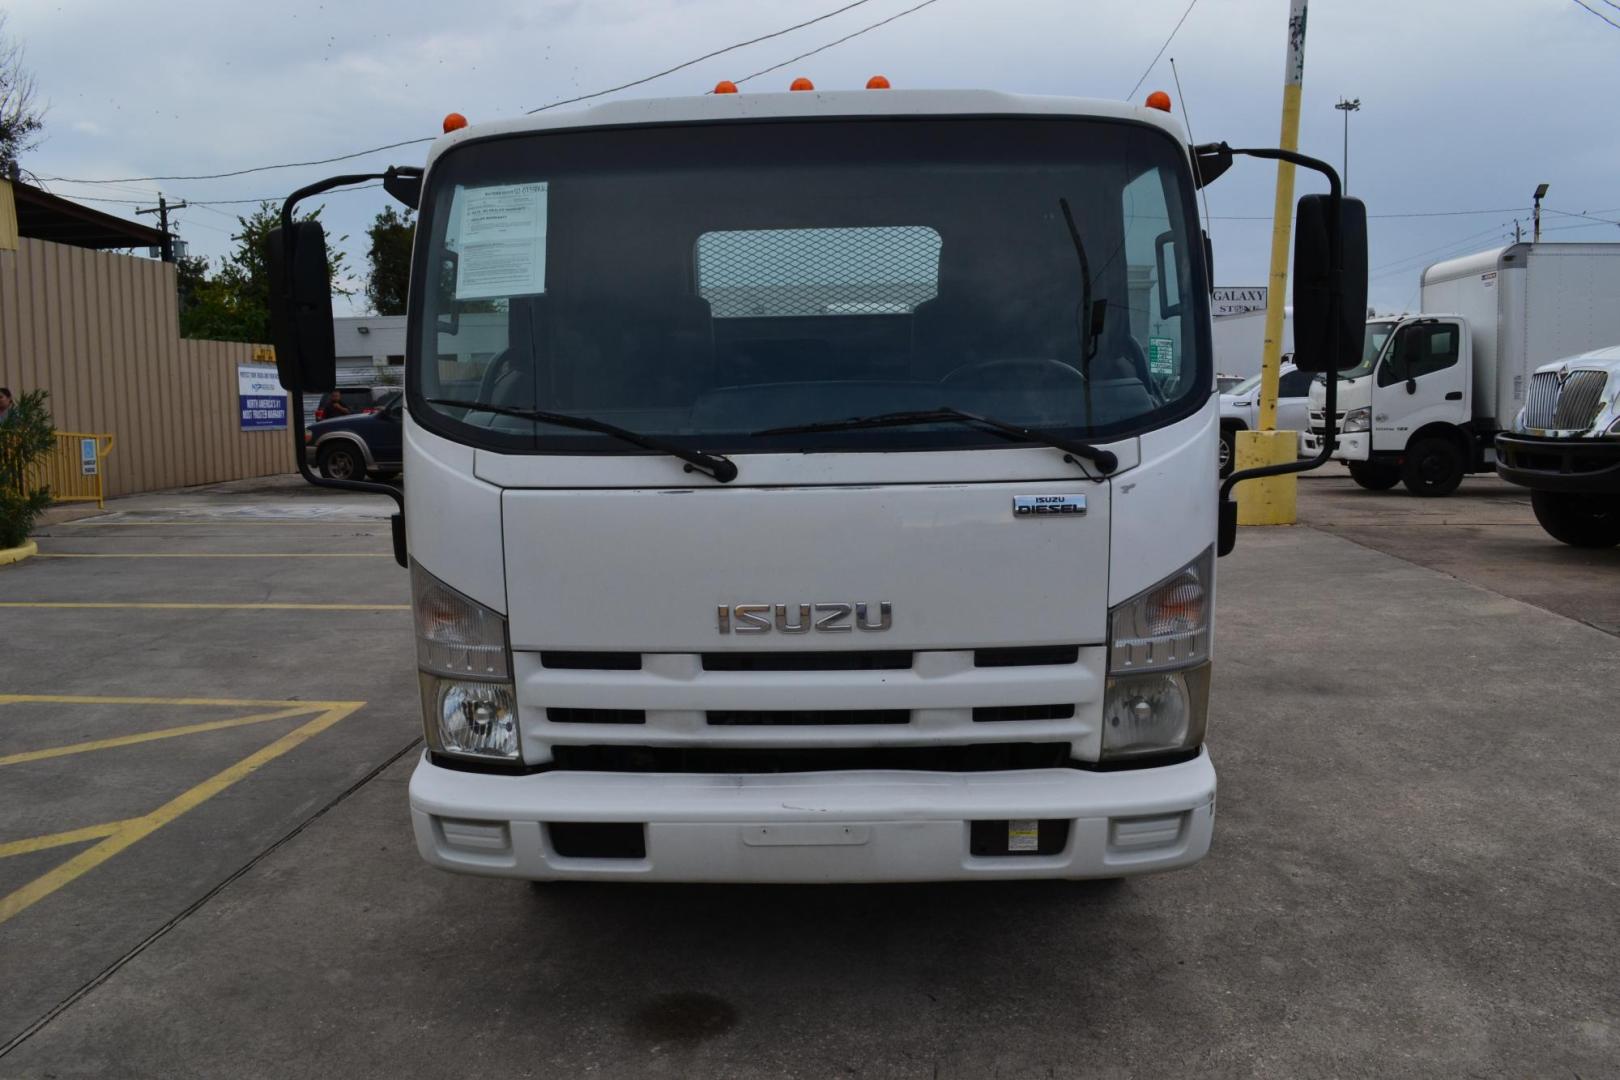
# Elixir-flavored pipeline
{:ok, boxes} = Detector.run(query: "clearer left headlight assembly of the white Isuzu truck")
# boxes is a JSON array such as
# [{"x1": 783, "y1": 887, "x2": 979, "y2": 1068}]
[{"x1": 411, "y1": 562, "x2": 522, "y2": 761}]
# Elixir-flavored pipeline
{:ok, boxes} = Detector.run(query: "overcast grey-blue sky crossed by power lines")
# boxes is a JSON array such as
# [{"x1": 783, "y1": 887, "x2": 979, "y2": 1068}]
[{"x1": 0, "y1": 0, "x2": 1620, "y2": 311}]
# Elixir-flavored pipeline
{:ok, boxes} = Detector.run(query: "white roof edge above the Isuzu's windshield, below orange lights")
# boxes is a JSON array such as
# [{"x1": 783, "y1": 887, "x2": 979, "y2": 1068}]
[{"x1": 428, "y1": 91, "x2": 1187, "y2": 168}]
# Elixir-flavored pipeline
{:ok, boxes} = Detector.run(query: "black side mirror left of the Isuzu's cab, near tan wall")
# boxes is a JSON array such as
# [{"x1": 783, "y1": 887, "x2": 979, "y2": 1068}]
[{"x1": 266, "y1": 222, "x2": 337, "y2": 393}]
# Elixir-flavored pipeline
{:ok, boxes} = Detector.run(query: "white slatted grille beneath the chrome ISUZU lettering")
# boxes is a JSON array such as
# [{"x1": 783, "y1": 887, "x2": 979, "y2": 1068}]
[{"x1": 514, "y1": 644, "x2": 1106, "y2": 772}]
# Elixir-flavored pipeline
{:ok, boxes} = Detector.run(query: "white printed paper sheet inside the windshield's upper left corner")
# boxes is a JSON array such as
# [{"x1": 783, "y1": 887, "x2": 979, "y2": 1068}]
[{"x1": 455, "y1": 181, "x2": 548, "y2": 300}]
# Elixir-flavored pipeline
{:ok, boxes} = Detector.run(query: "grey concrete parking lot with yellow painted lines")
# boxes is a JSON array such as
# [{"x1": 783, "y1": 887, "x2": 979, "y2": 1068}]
[{"x1": 0, "y1": 473, "x2": 1620, "y2": 1080}]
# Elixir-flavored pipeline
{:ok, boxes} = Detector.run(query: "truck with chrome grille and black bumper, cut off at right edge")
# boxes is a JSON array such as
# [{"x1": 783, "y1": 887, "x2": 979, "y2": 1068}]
[{"x1": 1497, "y1": 345, "x2": 1620, "y2": 547}]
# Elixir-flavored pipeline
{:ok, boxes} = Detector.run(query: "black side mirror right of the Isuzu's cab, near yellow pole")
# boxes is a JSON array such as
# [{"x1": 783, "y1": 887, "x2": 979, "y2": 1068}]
[{"x1": 1294, "y1": 194, "x2": 1367, "y2": 372}]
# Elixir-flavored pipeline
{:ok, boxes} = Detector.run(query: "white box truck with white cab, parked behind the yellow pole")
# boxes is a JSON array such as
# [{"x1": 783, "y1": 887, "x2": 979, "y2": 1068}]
[{"x1": 1304, "y1": 243, "x2": 1620, "y2": 495}]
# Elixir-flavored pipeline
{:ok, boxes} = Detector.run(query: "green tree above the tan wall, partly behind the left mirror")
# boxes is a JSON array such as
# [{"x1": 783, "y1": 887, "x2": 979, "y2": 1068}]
[{"x1": 177, "y1": 202, "x2": 353, "y2": 342}]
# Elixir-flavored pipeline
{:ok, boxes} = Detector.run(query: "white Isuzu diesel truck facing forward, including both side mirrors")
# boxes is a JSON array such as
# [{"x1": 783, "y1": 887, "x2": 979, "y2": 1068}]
[{"x1": 269, "y1": 89, "x2": 1366, "y2": 881}]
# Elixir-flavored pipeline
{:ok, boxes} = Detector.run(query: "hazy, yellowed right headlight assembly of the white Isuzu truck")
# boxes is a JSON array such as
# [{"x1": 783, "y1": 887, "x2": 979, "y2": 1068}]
[{"x1": 1102, "y1": 549, "x2": 1215, "y2": 758}]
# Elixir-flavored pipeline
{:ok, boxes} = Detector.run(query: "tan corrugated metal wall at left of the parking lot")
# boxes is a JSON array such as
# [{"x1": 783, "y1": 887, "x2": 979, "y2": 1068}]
[{"x1": 0, "y1": 240, "x2": 293, "y2": 495}]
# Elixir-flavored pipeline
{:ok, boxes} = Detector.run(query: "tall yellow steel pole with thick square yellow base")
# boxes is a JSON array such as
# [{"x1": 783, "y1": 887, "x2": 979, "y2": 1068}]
[{"x1": 1236, "y1": 0, "x2": 1306, "y2": 525}]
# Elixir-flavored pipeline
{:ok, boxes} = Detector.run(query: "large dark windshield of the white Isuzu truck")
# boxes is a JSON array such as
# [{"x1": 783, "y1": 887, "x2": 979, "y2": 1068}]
[{"x1": 408, "y1": 118, "x2": 1212, "y2": 453}]
